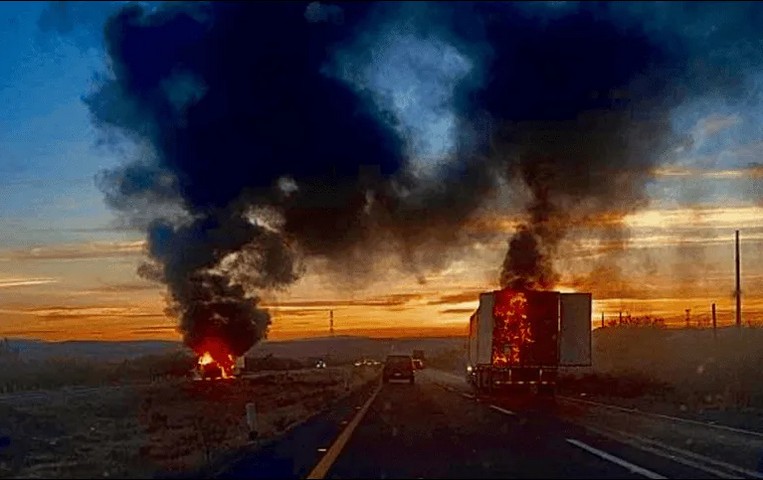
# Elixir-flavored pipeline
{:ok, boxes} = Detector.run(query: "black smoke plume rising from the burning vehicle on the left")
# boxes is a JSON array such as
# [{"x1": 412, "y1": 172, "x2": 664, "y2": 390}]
[{"x1": 87, "y1": 2, "x2": 502, "y2": 355}]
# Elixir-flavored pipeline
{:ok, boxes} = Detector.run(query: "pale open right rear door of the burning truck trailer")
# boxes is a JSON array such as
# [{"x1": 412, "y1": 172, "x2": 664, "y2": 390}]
[{"x1": 559, "y1": 293, "x2": 591, "y2": 367}]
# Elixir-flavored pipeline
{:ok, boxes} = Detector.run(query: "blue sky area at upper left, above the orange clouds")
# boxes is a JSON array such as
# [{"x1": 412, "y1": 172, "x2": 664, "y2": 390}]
[{"x1": 0, "y1": 2, "x2": 130, "y2": 248}]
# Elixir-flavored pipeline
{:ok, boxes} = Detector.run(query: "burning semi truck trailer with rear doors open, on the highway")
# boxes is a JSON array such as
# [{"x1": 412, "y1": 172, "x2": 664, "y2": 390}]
[{"x1": 467, "y1": 289, "x2": 591, "y2": 395}]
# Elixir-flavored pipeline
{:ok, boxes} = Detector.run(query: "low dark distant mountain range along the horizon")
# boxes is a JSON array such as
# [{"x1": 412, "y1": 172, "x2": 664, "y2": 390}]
[{"x1": 2, "y1": 336, "x2": 465, "y2": 361}]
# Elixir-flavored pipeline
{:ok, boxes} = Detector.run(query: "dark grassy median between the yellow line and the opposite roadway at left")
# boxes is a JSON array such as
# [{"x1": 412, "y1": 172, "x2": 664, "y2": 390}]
[{"x1": 0, "y1": 367, "x2": 378, "y2": 478}]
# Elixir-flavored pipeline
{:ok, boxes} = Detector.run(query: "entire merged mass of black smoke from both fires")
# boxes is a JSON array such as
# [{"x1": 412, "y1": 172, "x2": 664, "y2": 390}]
[{"x1": 87, "y1": 2, "x2": 760, "y2": 354}]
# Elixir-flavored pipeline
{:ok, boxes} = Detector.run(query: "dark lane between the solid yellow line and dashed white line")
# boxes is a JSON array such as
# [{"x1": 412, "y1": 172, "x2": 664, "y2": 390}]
[{"x1": 327, "y1": 375, "x2": 652, "y2": 479}]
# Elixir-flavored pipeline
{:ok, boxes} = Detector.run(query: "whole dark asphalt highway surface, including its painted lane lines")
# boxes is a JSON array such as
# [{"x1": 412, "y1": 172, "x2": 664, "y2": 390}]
[{"x1": 218, "y1": 370, "x2": 763, "y2": 479}]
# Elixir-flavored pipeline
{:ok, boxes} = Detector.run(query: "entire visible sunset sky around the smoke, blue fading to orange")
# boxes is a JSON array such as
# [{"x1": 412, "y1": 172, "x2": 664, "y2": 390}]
[{"x1": 0, "y1": 2, "x2": 763, "y2": 340}]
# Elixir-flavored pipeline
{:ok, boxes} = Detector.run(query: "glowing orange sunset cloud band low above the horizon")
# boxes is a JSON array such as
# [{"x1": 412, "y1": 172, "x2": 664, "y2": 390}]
[{"x1": 0, "y1": 202, "x2": 763, "y2": 340}]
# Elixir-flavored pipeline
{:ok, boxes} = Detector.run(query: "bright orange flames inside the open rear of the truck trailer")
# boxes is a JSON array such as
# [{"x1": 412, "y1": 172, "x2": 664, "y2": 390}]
[{"x1": 493, "y1": 290, "x2": 533, "y2": 365}]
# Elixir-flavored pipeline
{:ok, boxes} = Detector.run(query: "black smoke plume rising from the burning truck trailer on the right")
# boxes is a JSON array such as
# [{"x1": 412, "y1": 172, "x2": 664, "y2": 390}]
[{"x1": 454, "y1": 2, "x2": 679, "y2": 288}]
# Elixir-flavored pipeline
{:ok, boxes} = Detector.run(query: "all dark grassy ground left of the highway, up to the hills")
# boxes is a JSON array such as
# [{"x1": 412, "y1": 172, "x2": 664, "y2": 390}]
[{"x1": 0, "y1": 344, "x2": 378, "y2": 478}]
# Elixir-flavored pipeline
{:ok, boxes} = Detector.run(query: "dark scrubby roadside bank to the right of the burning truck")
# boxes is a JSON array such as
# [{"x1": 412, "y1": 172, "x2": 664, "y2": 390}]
[{"x1": 560, "y1": 324, "x2": 763, "y2": 413}]
